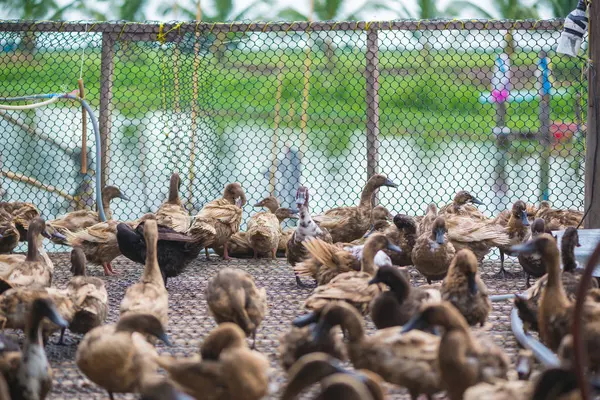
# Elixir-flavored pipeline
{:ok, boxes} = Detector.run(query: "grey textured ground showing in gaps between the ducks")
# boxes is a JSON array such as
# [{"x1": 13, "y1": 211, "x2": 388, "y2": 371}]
[{"x1": 9, "y1": 253, "x2": 536, "y2": 399}]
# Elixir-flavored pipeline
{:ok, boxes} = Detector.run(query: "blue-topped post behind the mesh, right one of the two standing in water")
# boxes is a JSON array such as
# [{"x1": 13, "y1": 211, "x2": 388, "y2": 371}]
[{"x1": 538, "y1": 51, "x2": 552, "y2": 201}]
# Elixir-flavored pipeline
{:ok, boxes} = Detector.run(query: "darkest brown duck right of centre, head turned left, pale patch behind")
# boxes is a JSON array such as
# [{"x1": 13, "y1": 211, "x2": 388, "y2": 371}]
[{"x1": 369, "y1": 266, "x2": 442, "y2": 329}]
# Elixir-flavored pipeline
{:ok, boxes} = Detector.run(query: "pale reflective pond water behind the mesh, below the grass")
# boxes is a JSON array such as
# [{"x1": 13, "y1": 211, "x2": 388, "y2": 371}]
[{"x1": 0, "y1": 107, "x2": 584, "y2": 253}]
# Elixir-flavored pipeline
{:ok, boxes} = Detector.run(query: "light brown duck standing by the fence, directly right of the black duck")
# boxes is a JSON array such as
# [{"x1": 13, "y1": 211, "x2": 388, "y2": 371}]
[{"x1": 188, "y1": 182, "x2": 246, "y2": 260}]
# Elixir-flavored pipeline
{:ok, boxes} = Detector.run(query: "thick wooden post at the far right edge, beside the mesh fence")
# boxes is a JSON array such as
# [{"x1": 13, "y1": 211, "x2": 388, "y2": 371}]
[{"x1": 584, "y1": 2, "x2": 600, "y2": 229}]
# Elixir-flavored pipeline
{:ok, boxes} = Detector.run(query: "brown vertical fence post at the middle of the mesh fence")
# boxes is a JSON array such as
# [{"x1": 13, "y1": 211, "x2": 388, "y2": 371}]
[{"x1": 365, "y1": 24, "x2": 379, "y2": 198}]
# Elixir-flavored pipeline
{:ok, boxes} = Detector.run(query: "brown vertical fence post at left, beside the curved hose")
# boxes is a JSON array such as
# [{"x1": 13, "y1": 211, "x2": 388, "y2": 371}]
[{"x1": 96, "y1": 33, "x2": 115, "y2": 187}]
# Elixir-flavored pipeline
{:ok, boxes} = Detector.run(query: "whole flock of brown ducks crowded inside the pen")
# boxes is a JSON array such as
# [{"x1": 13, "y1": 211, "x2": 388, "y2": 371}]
[{"x1": 0, "y1": 173, "x2": 600, "y2": 400}]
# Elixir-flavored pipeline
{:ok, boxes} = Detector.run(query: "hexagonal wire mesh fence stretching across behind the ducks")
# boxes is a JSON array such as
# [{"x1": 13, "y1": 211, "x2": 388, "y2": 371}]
[{"x1": 0, "y1": 20, "x2": 587, "y2": 234}]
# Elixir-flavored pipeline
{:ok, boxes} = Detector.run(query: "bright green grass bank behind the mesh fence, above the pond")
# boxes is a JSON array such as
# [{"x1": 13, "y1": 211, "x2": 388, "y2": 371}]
[{"x1": 0, "y1": 41, "x2": 585, "y2": 154}]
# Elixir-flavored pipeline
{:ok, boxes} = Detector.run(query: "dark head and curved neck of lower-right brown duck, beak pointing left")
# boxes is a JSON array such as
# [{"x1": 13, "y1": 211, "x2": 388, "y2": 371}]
[{"x1": 402, "y1": 301, "x2": 469, "y2": 332}]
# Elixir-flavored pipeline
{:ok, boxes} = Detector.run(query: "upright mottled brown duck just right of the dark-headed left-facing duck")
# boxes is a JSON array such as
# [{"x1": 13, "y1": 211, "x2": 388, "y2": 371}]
[{"x1": 441, "y1": 249, "x2": 492, "y2": 326}]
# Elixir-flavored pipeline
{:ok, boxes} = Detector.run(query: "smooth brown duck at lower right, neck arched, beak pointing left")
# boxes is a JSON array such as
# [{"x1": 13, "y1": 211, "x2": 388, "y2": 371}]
[{"x1": 403, "y1": 302, "x2": 509, "y2": 400}]
